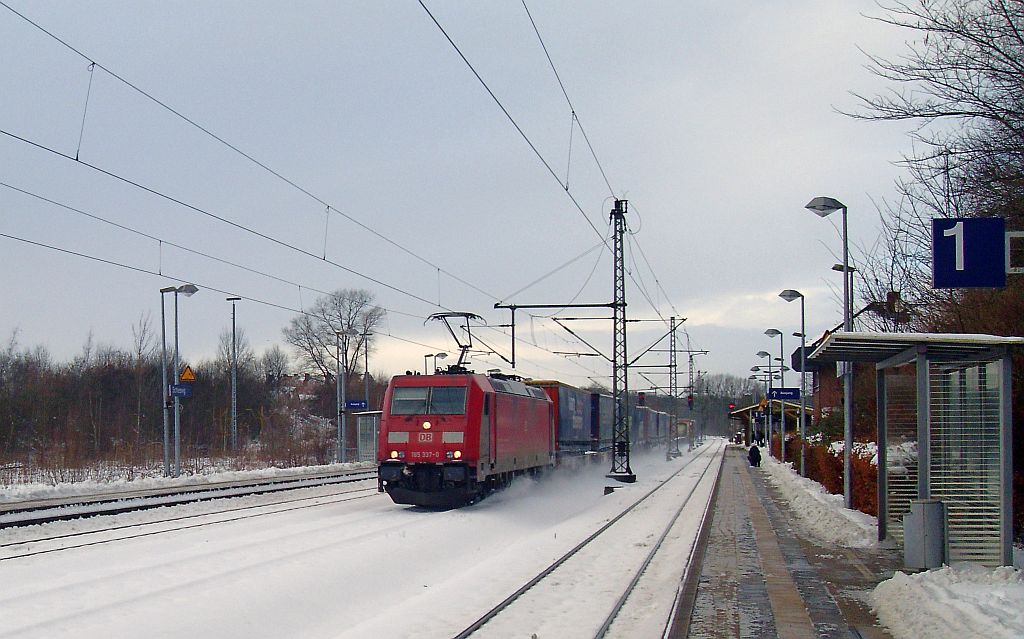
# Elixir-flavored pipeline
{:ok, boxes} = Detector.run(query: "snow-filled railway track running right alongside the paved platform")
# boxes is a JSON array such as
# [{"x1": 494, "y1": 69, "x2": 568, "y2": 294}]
[{"x1": 455, "y1": 438, "x2": 721, "y2": 639}]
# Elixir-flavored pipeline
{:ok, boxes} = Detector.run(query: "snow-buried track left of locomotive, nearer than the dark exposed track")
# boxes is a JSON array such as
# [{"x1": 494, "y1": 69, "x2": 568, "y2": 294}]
[{"x1": 0, "y1": 484, "x2": 379, "y2": 562}]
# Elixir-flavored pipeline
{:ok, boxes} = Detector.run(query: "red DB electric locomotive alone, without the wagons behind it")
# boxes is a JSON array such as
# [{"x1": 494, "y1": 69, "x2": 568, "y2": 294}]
[{"x1": 377, "y1": 367, "x2": 555, "y2": 507}]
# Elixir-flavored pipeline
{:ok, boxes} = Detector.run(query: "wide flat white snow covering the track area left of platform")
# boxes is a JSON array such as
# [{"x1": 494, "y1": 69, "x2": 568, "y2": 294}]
[{"x1": 0, "y1": 440, "x2": 724, "y2": 639}]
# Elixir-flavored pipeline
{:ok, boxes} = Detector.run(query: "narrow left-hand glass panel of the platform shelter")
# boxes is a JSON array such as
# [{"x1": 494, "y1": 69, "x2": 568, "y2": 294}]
[{"x1": 886, "y1": 367, "x2": 918, "y2": 544}]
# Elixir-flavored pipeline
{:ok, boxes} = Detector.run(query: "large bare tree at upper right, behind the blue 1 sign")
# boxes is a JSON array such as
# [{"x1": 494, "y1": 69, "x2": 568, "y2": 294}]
[{"x1": 851, "y1": 0, "x2": 1024, "y2": 331}]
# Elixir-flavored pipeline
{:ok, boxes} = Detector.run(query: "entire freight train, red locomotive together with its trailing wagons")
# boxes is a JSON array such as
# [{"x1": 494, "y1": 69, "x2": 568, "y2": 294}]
[{"x1": 377, "y1": 366, "x2": 669, "y2": 508}]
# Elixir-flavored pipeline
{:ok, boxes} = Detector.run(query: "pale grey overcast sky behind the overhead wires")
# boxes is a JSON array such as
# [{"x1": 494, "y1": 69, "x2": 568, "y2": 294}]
[{"x1": 0, "y1": 0, "x2": 909, "y2": 388}]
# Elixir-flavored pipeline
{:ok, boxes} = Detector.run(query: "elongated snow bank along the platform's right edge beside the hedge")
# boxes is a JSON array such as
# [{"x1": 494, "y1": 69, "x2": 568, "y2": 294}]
[{"x1": 762, "y1": 458, "x2": 878, "y2": 548}]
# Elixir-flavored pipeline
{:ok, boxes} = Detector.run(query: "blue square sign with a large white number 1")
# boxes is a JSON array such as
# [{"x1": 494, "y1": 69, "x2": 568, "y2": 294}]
[{"x1": 932, "y1": 217, "x2": 1007, "y2": 289}]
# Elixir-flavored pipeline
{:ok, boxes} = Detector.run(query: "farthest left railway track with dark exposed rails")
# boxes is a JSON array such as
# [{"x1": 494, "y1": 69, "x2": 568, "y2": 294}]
[{"x1": 0, "y1": 469, "x2": 377, "y2": 529}]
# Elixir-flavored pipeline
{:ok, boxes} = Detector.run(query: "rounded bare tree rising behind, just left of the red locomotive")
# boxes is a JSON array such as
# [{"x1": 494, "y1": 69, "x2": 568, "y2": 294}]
[{"x1": 284, "y1": 289, "x2": 385, "y2": 381}]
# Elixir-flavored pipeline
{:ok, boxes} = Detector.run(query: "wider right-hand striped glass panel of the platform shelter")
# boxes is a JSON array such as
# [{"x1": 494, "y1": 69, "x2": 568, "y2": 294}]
[{"x1": 929, "y1": 363, "x2": 1002, "y2": 565}]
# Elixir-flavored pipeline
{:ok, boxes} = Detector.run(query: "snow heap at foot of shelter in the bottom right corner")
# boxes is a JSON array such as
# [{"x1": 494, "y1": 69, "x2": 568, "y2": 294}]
[{"x1": 871, "y1": 563, "x2": 1024, "y2": 639}]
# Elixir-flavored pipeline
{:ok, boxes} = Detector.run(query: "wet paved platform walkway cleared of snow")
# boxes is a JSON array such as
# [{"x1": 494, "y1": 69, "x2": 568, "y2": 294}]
[{"x1": 677, "y1": 446, "x2": 901, "y2": 639}]
